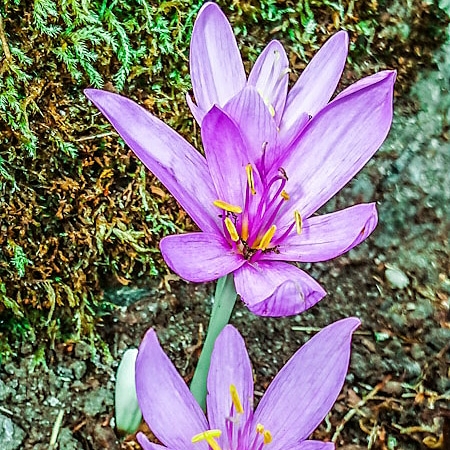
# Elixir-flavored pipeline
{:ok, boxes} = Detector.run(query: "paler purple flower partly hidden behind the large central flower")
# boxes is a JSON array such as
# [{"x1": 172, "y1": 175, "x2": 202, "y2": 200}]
[{"x1": 186, "y1": 3, "x2": 348, "y2": 147}]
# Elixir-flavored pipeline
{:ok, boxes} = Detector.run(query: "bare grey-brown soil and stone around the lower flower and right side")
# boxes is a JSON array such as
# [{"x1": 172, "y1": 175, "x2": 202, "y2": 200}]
[{"x1": 0, "y1": 22, "x2": 450, "y2": 450}]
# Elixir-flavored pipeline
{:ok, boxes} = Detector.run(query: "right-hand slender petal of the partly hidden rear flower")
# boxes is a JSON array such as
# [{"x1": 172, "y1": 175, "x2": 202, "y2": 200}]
[{"x1": 280, "y1": 31, "x2": 348, "y2": 126}]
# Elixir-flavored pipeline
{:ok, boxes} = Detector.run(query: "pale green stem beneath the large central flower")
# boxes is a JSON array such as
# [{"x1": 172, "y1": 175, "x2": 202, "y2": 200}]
[{"x1": 191, "y1": 275, "x2": 236, "y2": 409}]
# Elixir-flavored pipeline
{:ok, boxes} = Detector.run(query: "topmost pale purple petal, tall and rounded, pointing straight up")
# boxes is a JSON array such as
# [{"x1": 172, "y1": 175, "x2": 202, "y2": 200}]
[{"x1": 190, "y1": 3, "x2": 246, "y2": 112}]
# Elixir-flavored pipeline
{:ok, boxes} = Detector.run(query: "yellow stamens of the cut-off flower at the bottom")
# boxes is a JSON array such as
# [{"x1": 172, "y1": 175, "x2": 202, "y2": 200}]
[{"x1": 191, "y1": 384, "x2": 272, "y2": 450}]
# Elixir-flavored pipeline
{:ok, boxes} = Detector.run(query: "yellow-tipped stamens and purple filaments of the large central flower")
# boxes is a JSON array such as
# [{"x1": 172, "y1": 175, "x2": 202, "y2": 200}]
[{"x1": 214, "y1": 164, "x2": 302, "y2": 261}]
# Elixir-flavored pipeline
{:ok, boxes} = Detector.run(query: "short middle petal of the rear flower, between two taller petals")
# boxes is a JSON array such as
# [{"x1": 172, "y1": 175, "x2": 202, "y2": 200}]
[{"x1": 248, "y1": 41, "x2": 289, "y2": 125}]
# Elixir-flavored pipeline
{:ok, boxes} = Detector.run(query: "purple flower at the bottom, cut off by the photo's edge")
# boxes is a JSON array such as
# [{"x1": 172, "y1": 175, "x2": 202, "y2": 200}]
[{"x1": 136, "y1": 318, "x2": 360, "y2": 450}]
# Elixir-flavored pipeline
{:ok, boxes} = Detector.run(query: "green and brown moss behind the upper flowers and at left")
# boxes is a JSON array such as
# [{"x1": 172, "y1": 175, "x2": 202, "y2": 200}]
[{"x1": 0, "y1": 0, "x2": 448, "y2": 356}]
